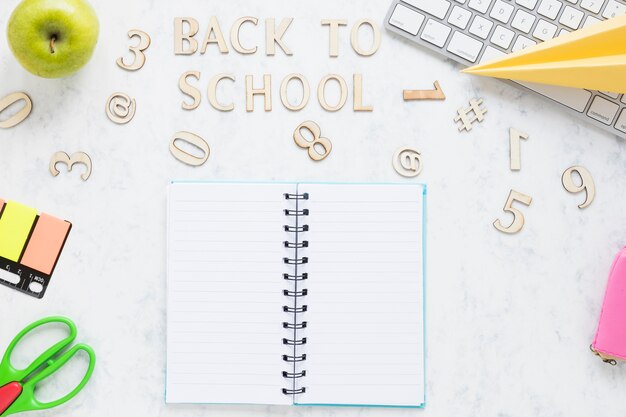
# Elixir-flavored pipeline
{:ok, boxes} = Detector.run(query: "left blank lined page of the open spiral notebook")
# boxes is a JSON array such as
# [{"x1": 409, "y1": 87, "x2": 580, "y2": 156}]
[{"x1": 166, "y1": 184, "x2": 295, "y2": 404}]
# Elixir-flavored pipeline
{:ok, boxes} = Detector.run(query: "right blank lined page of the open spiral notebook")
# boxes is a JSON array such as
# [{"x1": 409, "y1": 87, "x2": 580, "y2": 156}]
[{"x1": 296, "y1": 184, "x2": 424, "y2": 406}]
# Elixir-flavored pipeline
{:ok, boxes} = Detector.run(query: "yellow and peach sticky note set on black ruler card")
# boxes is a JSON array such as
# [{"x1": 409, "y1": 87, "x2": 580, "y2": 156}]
[{"x1": 0, "y1": 200, "x2": 72, "y2": 298}]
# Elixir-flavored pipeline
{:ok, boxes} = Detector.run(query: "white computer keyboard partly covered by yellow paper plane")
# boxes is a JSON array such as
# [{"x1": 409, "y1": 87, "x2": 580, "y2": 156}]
[{"x1": 385, "y1": 0, "x2": 626, "y2": 139}]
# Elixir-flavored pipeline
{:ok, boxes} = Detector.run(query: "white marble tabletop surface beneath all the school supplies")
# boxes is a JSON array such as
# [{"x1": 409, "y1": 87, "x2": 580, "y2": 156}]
[{"x1": 0, "y1": 0, "x2": 626, "y2": 417}]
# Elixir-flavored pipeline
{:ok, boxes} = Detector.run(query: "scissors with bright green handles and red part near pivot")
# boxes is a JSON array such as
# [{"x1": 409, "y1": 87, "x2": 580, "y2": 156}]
[{"x1": 0, "y1": 317, "x2": 96, "y2": 417}]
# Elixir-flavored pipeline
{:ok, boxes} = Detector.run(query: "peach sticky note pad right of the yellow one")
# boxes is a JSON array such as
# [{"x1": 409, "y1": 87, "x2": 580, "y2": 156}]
[{"x1": 21, "y1": 213, "x2": 71, "y2": 275}]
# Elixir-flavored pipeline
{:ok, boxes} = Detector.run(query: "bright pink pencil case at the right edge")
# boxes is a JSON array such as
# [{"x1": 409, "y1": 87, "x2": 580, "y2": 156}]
[{"x1": 591, "y1": 248, "x2": 626, "y2": 365}]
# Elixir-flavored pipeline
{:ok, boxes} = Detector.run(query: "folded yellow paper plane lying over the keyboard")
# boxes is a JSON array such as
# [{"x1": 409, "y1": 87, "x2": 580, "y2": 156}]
[{"x1": 463, "y1": 15, "x2": 626, "y2": 93}]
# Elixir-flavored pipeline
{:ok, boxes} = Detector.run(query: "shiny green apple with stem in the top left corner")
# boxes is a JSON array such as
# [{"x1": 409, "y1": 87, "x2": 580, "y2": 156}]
[{"x1": 7, "y1": 0, "x2": 99, "y2": 78}]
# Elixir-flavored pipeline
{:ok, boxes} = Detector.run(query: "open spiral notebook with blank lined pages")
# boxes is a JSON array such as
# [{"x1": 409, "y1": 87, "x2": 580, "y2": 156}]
[{"x1": 166, "y1": 182, "x2": 426, "y2": 407}]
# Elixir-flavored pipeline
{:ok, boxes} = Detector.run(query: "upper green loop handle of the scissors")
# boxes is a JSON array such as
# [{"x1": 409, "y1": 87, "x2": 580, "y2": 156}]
[{"x1": 0, "y1": 317, "x2": 76, "y2": 386}]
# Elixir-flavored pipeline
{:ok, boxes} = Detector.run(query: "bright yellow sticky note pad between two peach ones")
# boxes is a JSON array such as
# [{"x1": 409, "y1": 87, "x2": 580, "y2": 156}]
[{"x1": 0, "y1": 201, "x2": 37, "y2": 262}]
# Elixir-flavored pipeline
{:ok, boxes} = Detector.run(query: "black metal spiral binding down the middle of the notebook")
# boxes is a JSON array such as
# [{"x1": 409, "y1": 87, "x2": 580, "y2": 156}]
[{"x1": 282, "y1": 193, "x2": 309, "y2": 395}]
